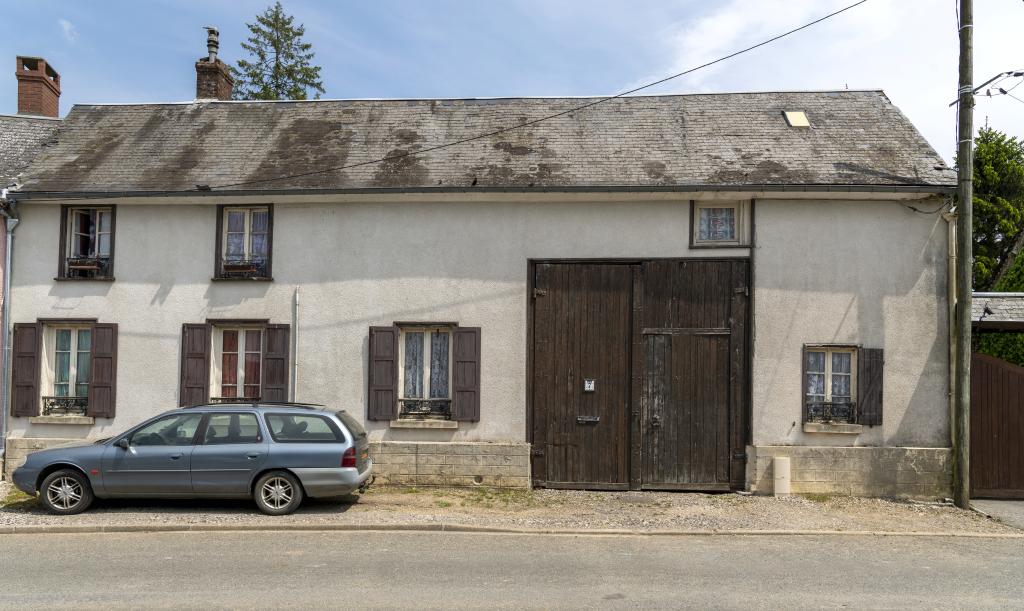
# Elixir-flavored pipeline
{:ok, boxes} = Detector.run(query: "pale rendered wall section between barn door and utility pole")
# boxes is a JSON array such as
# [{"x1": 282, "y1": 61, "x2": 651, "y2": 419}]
[{"x1": 748, "y1": 202, "x2": 950, "y2": 491}]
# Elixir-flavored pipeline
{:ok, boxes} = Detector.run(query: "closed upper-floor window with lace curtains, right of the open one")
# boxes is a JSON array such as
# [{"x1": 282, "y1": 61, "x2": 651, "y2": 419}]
[{"x1": 217, "y1": 206, "x2": 272, "y2": 278}]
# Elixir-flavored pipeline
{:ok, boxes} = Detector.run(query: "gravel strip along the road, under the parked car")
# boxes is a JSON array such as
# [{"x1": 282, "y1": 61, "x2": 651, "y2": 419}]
[{"x1": 0, "y1": 482, "x2": 1021, "y2": 534}]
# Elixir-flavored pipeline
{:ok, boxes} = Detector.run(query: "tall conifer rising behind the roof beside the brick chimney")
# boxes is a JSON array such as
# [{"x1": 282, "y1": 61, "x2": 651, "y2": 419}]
[{"x1": 231, "y1": 2, "x2": 324, "y2": 99}]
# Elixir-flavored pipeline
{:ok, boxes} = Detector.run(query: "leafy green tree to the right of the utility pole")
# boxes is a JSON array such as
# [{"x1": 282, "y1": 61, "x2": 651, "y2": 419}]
[{"x1": 974, "y1": 128, "x2": 1024, "y2": 291}]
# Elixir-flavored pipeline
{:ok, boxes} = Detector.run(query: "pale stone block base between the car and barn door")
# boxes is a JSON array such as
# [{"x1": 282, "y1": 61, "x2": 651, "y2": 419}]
[{"x1": 370, "y1": 441, "x2": 530, "y2": 488}]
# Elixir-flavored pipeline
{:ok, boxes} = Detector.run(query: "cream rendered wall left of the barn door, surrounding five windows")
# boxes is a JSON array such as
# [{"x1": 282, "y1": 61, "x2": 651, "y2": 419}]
[{"x1": 4, "y1": 195, "x2": 745, "y2": 441}]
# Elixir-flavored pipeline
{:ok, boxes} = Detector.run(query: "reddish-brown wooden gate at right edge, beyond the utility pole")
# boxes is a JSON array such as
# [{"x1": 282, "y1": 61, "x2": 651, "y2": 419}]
[{"x1": 971, "y1": 353, "x2": 1024, "y2": 498}]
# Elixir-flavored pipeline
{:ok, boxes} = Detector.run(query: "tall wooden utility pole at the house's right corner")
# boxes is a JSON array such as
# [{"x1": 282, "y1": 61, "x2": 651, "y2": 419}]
[{"x1": 953, "y1": 0, "x2": 974, "y2": 509}]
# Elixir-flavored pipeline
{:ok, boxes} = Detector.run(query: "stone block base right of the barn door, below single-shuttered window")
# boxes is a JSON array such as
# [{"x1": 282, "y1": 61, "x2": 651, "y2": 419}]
[{"x1": 746, "y1": 445, "x2": 952, "y2": 499}]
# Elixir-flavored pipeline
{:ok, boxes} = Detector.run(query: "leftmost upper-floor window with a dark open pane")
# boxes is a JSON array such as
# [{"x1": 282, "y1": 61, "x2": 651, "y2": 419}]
[{"x1": 59, "y1": 206, "x2": 114, "y2": 278}]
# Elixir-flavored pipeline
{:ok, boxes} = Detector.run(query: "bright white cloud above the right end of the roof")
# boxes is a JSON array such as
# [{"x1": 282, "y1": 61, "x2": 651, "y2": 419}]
[{"x1": 634, "y1": 0, "x2": 1024, "y2": 161}]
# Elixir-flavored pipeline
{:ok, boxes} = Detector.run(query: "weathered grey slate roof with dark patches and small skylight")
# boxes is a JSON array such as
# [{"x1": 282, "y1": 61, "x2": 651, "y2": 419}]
[{"x1": 16, "y1": 91, "x2": 954, "y2": 192}]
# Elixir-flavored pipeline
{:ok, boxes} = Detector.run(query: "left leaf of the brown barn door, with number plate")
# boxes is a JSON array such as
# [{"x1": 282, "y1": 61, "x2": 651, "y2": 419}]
[{"x1": 532, "y1": 263, "x2": 636, "y2": 489}]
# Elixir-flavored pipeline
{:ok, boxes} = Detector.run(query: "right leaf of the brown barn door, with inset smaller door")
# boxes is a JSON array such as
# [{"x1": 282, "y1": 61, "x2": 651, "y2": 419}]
[{"x1": 638, "y1": 259, "x2": 749, "y2": 490}]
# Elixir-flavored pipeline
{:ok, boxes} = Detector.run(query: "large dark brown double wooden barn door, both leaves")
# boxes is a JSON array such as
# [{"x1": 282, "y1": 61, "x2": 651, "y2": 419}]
[{"x1": 531, "y1": 259, "x2": 749, "y2": 490}]
